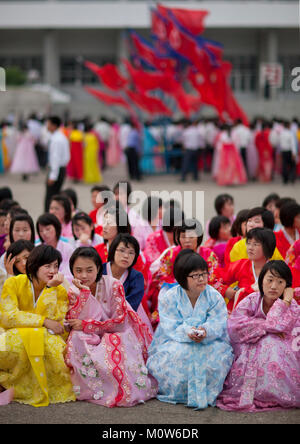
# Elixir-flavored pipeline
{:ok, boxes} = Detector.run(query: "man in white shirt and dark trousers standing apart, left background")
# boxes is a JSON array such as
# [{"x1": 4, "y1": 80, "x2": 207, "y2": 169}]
[{"x1": 45, "y1": 116, "x2": 70, "y2": 212}]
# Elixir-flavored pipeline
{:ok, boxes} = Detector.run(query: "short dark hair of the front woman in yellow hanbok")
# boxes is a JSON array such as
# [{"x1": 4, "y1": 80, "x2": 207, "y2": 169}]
[{"x1": 26, "y1": 244, "x2": 62, "y2": 281}]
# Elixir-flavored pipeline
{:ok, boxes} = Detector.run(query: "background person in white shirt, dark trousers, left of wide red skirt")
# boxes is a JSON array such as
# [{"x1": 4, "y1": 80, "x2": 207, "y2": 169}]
[{"x1": 181, "y1": 122, "x2": 200, "y2": 182}]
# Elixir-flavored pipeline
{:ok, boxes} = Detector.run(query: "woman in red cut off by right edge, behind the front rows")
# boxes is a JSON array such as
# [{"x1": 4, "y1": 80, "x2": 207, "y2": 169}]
[{"x1": 275, "y1": 202, "x2": 300, "y2": 258}]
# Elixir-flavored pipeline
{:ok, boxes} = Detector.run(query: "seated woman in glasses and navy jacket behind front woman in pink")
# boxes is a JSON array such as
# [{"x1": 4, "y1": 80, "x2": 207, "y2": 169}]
[{"x1": 103, "y1": 233, "x2": 153, "y2": 333}]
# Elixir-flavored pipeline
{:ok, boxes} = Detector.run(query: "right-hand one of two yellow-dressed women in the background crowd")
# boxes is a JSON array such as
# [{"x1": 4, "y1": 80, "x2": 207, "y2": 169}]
[{"x1": 83, "y1": 125, "x2": 102, "y2": 183}]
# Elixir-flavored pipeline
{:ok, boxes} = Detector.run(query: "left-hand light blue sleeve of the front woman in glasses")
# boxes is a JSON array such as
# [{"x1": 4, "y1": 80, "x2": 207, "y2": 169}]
[{"x1": 158, "y1": 289, "x2": 193, "y2": 342}]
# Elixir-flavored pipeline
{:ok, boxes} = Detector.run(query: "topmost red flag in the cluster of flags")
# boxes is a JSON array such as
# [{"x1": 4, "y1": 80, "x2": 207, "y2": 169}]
[{"x1": 157, "y1": 5, "x2": 209, "y2": 35}]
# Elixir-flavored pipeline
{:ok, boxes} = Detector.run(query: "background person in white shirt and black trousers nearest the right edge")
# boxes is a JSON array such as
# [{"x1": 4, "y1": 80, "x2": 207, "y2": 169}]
[{"x1": 279, "y1": 121, "x2": 297, "y2": 184}]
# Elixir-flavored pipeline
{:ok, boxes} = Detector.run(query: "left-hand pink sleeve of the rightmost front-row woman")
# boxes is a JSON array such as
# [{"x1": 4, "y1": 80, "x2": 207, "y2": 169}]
[{"x1": 228, "y1": 294, "x2": 267, "y2": 344}]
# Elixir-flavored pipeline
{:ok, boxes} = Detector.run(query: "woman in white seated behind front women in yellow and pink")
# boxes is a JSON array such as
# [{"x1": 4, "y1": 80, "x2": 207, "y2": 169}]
[{"x1": 36, "y1": 213, "x2": 74, "y2": 282}]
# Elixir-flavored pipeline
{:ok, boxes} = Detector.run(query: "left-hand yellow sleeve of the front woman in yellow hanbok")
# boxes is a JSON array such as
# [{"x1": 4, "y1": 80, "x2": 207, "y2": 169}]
[{"x1": 0, "y1": 277, "x2": 46, "y2": 328}]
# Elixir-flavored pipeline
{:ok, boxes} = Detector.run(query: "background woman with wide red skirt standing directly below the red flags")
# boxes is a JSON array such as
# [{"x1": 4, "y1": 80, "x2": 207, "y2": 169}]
[{"x1": 214, "y1": 126, "x2": 247, "y2": 186}]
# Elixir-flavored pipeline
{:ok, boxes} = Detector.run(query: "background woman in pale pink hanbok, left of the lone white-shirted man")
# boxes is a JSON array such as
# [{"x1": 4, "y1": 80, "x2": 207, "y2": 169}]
[{"x1": 10, "y1": 125, "x2": 40, "y2": 180}]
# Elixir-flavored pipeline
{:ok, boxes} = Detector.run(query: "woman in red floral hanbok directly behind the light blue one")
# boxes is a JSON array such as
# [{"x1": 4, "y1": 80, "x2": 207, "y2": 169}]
[{"x1": 147, "y1": 219, "x2": 219, "y2": 326}]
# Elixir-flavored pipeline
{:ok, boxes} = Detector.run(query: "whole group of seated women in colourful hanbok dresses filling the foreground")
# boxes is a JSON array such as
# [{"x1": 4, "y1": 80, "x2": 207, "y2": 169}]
[{"x1": 0, "y1": 185, "x2": 300, "y2": 412}]
